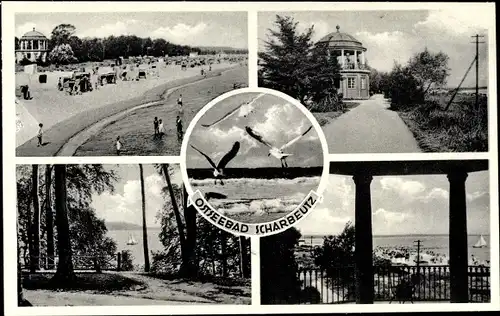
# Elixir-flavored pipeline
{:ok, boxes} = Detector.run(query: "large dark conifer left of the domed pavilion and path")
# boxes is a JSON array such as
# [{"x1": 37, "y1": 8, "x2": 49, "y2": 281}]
[{"x1": 259, "y1": 15, "x2": 340, "y2": 108}]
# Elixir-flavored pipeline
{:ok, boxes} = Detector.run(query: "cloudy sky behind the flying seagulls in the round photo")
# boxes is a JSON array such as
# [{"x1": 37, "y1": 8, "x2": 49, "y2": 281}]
[{"x1": 186, "y1": 92, "x2": 323, "y2": 168}]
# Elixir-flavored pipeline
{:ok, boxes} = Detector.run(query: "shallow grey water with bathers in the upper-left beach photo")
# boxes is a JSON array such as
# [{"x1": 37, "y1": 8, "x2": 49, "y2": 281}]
[{"x1": 74, "y1": 67, "x2": 248, "y2": 156}]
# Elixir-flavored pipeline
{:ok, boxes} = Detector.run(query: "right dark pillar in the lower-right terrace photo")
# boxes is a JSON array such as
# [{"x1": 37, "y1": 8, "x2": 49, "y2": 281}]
[{"x1": 448, "y1": 171, "x2": 469, "y2": 303}]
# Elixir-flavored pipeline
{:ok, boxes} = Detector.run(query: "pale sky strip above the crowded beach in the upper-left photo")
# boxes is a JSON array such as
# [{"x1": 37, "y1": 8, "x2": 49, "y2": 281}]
[{"x1": 15, "y1": 12, "x2": 248, "y2": 48}]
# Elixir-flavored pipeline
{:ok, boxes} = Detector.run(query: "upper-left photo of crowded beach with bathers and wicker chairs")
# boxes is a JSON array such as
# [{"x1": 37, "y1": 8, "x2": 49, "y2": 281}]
[{"x1": 15, "y1": 12, "x2": 248, "y2": 157}]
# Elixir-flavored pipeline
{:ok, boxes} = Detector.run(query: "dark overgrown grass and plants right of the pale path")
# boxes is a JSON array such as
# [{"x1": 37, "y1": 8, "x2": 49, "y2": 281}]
[{"x1": 395, "y1": 94, "x2": 488, "y2": 152}]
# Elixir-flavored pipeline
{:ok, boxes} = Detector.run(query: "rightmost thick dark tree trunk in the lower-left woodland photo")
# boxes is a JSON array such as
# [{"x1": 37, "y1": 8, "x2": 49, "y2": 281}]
[{"x1": 182, "y1": 185, "x2": 198, "y2": 278}]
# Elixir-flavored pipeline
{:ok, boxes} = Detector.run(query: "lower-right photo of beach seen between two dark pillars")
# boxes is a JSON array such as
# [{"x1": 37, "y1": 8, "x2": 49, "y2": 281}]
[{"x1": 260, "y1": 160, "x2": 493, "y2": 304}]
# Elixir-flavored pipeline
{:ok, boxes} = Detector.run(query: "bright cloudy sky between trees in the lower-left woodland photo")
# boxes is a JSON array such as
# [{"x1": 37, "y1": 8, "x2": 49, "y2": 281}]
[{"x1": 92, "y1": 164, "x2": 182, "y2": 227}]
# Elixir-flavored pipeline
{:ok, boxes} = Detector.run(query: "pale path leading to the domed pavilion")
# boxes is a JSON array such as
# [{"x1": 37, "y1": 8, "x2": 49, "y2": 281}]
[{"x1": 323, "y1": 95, "x2": 421, "y2": 154}]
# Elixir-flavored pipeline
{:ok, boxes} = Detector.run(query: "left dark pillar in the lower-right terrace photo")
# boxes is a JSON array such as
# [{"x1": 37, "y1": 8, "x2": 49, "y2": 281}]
[{"x1": 353, "y1": 174, "x2": 374, "y2": 304}]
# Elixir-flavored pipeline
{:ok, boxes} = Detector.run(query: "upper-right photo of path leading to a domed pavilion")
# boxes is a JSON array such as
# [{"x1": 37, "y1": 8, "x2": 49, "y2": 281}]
[{"x1": 258, "y1": 8, "x2": 490, "y2": 154}]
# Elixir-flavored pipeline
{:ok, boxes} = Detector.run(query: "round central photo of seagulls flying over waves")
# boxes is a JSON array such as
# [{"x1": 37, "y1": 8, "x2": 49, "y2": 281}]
[{"x1": 186, "y1": 92, "x2": 325, "y2": 223}]
